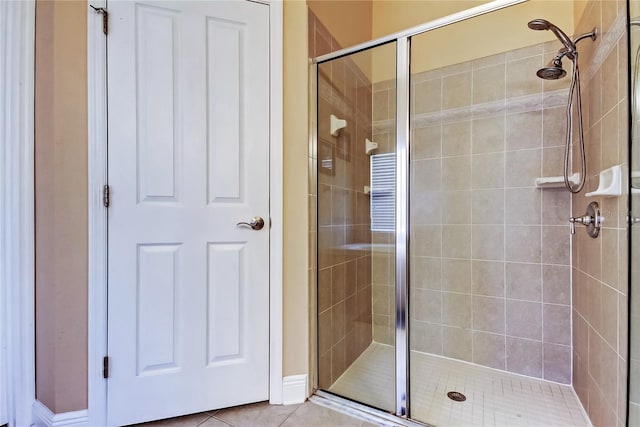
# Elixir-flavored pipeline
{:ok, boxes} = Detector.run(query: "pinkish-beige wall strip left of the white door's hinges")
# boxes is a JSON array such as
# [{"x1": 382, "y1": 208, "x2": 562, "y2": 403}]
[{"x1": 35, "y1": 1, "x2": 87, "y2": 413}]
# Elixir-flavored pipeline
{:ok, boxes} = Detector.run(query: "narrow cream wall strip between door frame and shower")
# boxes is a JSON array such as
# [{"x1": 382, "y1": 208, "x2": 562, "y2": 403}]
[{"x1": 282, "y1": 0, "x2": 309, "y2": 376}]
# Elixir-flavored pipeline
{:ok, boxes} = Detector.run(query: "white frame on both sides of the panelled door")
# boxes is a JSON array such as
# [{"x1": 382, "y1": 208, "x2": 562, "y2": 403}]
[{"x1": 87, "y1": 0, "x2": 283, "y2": 425}]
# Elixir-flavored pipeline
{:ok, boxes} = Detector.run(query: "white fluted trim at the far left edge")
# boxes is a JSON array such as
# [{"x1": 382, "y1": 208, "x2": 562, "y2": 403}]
[{"x1": 0, "y1": 0, "x2": 35, "y2": 426}]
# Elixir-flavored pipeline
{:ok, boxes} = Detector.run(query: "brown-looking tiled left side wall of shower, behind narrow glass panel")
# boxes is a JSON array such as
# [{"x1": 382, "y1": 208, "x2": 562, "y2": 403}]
[{"x1": 309, "y1": 12, "x2": 372, "y2": 389}]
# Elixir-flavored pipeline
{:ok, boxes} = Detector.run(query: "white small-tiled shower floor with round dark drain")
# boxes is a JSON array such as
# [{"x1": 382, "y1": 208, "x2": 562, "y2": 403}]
[{"x1": 329, "y1": 343, "x2": 591, "y2": 427}]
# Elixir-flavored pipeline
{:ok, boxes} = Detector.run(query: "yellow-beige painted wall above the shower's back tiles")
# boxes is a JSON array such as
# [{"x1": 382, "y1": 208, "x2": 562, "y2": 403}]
[{"x1": 373, "y1": 0, "x2": 573, "y2": 82}]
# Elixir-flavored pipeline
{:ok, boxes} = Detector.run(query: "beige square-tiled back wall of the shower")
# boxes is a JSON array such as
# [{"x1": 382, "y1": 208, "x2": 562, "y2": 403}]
[{"x1": 373, "y1": 43, "x2": 571, "y2": 383}]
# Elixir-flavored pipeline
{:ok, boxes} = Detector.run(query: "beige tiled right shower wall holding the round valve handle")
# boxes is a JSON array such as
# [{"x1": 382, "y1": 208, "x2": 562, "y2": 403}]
[{"x1": 573, "y1": 0, "x2": 628, "y2": 427}]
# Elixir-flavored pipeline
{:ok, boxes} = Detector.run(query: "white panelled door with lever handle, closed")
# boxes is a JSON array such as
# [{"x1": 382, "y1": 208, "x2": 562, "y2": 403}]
[{"x1": 107, "y1": 1, "x2": 269, "y2": 425}]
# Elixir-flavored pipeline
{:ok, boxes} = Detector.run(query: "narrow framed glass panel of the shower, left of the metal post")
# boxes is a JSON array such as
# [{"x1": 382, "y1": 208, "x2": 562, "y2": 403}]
[{"x1": 315, "y1": 43, "x2": 396, "y2": 412}]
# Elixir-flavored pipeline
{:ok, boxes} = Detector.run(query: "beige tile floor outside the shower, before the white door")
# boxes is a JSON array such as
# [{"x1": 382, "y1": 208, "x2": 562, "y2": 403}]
[{"x1": 136, "y1": 402, "x2": 376, "y2": 427}]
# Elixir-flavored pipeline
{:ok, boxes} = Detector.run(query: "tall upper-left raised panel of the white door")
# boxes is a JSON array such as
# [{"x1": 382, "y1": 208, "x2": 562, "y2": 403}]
[{"x1": 135, "y1": 5, "x2": 182, "y2": 202}]
